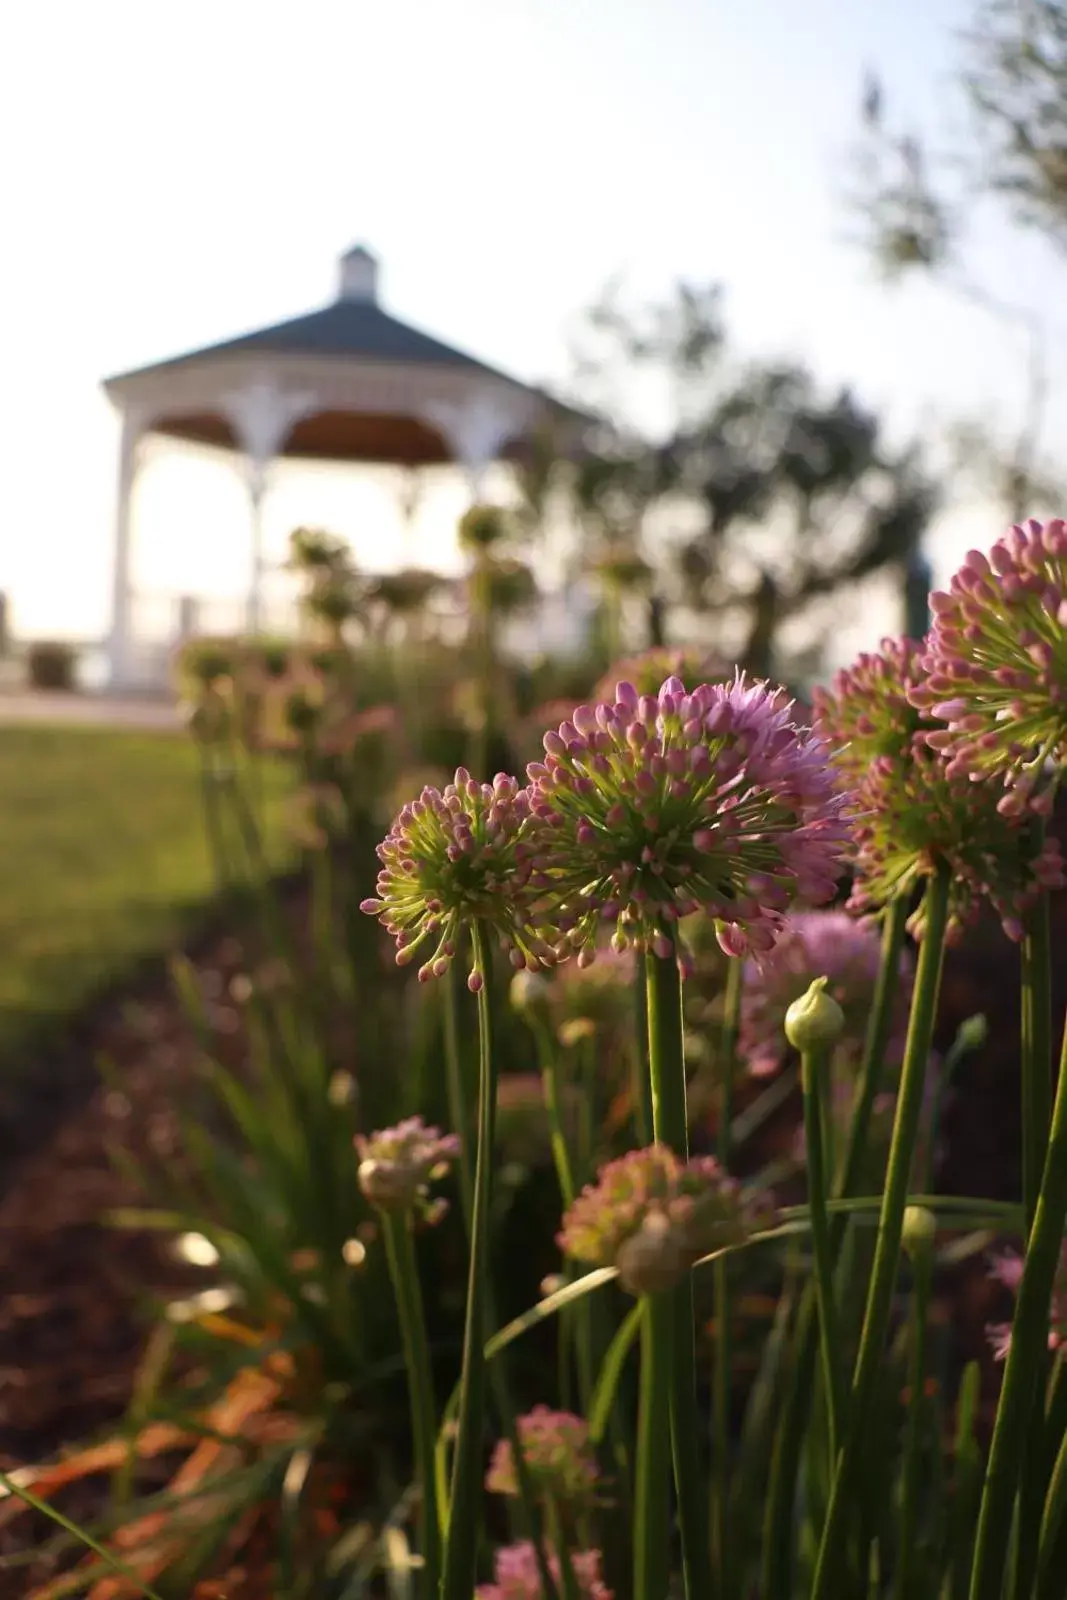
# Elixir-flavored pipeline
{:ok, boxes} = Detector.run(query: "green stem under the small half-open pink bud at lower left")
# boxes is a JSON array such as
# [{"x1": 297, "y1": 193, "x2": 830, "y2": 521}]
[{"x1": 379, "y1": 1211, "x2": 442, "y2": 1595}]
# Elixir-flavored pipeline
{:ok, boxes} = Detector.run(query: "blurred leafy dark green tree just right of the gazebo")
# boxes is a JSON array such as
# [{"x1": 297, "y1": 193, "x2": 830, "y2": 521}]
[{"x1": 524, "y1": 283, "x2": 936, "y2": 675}]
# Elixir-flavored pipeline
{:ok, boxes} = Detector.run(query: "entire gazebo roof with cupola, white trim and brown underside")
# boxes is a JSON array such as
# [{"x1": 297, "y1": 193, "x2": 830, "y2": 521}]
[{"x1": 104, "y1": 245, "x2": 590, "y2": 466}]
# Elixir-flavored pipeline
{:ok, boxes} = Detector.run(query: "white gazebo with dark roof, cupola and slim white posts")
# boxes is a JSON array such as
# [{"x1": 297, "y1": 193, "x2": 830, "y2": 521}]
[{"x1": 104, "y1": 245, "x2": 587, "y2": 690}]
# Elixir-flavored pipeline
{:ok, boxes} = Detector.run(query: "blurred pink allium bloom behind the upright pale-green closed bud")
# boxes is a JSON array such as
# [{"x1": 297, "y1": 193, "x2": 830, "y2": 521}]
[{"x1": 739, "y1": 910, "x2": 913, "y2": 1077}]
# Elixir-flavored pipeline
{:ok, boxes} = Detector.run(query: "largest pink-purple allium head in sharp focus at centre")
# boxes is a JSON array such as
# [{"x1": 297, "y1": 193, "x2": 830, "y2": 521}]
[{"x1": 528, "y1": 675, "x2": 846, "y2": 962}]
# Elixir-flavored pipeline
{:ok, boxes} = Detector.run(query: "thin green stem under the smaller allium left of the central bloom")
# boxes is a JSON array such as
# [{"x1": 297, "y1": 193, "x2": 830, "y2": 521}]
[{"x1": 442, "y1": 922, "x2": 496, "y2": 1600}]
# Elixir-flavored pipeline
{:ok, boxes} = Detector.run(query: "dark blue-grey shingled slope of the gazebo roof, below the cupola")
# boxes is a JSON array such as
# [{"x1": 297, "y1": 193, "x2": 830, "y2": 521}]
[{"x1": 109, "y1": 299, "x2": 531, "y2": 382}]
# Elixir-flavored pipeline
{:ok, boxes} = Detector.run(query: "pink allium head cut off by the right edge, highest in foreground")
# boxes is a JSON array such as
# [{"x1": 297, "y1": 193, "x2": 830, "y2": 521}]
[{"x1": 912, "y1": 517, "x2": 1067, "y2": 814}]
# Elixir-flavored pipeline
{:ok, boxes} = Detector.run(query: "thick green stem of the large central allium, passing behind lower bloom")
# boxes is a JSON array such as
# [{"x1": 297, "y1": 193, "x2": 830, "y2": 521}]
[{"x1": 645, "y1": 947, "x2": 713, "y2": 1600}]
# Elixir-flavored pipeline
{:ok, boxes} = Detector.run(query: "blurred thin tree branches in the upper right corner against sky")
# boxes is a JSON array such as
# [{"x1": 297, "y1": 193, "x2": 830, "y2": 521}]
[{"x1": 849, "y1": 0, "x2": 1067, "y2": 520}]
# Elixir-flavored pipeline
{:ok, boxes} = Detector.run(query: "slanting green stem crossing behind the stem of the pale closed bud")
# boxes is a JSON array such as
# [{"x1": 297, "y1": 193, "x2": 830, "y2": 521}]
[{"x1": 760, "y1": 899, "x2": 909, "y2": 1600}]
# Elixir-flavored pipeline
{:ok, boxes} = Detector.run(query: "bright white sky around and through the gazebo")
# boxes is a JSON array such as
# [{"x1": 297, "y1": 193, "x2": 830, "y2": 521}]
[{"x1": 0, "y1": 0, "x2": 1067, "y2": 649}]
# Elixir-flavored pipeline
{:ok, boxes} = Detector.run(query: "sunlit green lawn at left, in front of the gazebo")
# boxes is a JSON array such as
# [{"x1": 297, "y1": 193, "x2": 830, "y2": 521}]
[{"x1": 0, "y1": 725, "x2": 295, "y2": 1059}]
